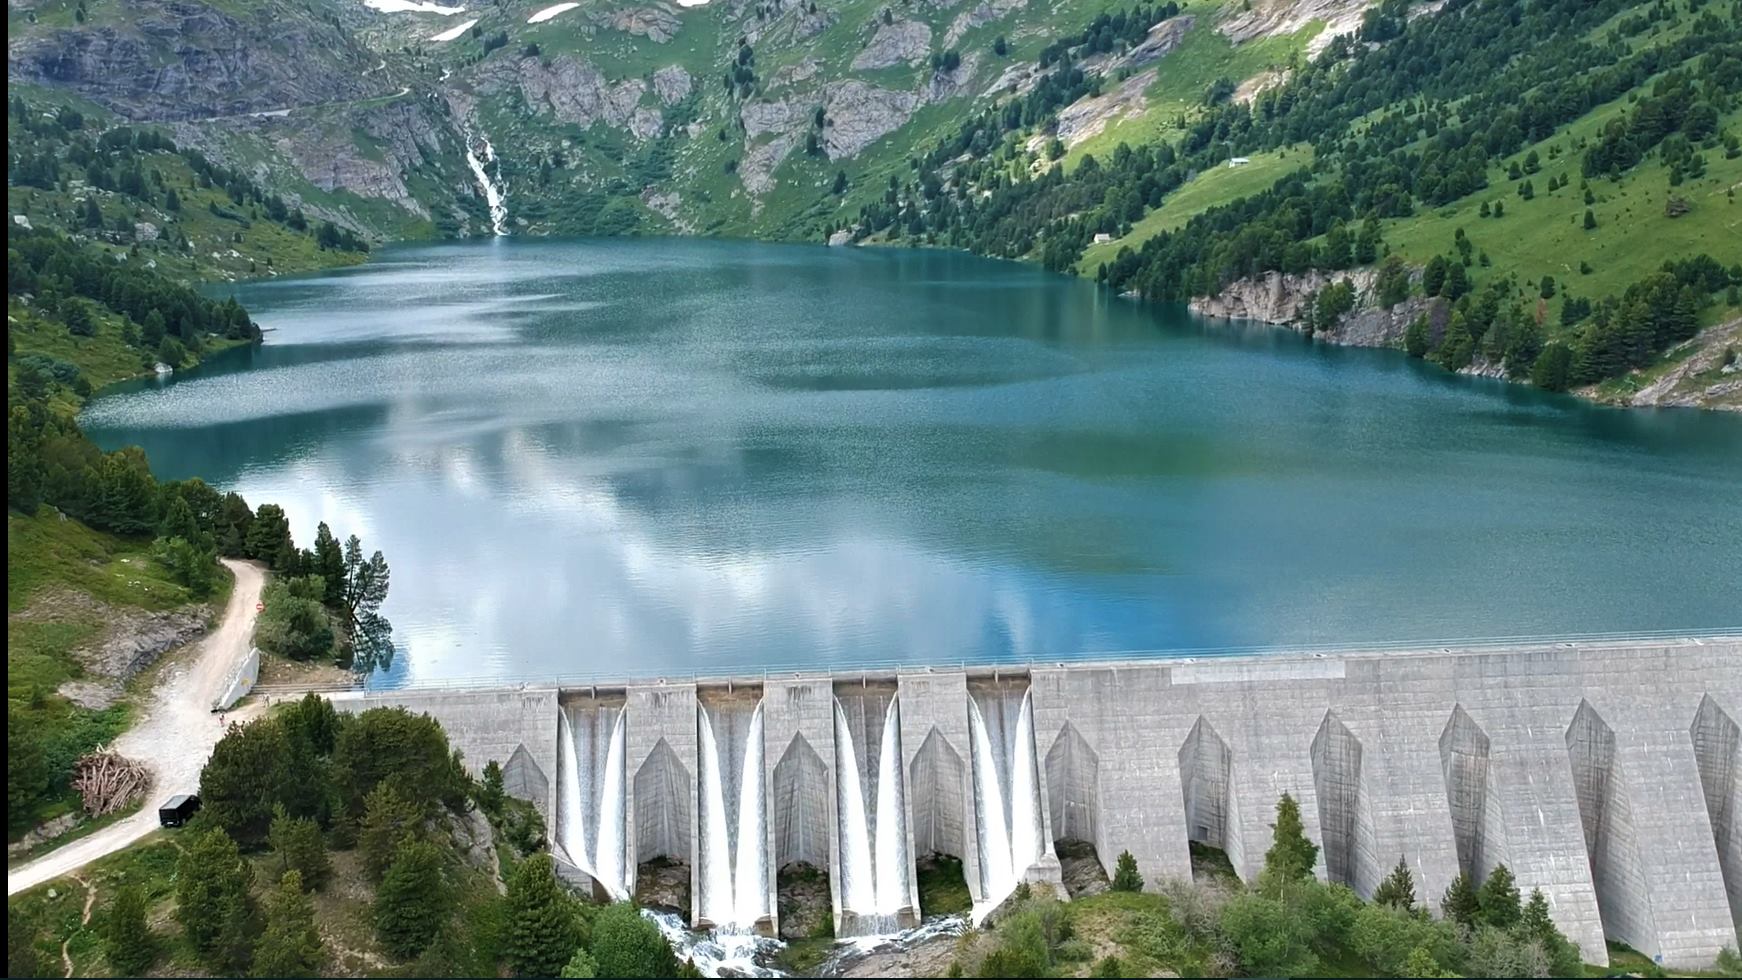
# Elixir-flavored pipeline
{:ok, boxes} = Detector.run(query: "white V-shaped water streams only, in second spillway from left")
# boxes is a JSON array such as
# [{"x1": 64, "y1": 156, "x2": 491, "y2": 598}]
[{"x1": 700, "y1": 703, "x2": 768, "y2": 933}]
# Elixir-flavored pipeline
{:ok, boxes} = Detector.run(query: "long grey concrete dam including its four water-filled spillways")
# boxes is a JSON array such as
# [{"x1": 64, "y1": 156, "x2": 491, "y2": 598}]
[{"x1": 338, "y1": 635, "x2": 1742, "y2": 968}]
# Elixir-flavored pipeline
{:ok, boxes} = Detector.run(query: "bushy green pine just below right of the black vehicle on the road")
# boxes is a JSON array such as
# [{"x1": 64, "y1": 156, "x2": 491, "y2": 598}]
[{"x1": 176, "y1": 827, "x2": 258, "y2": 973}]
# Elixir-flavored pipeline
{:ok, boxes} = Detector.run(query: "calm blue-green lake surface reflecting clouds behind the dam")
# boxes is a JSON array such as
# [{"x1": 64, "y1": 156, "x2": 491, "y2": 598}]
[{"x1": 85, "y1": 240, "x2": 1742, "y2": 682}]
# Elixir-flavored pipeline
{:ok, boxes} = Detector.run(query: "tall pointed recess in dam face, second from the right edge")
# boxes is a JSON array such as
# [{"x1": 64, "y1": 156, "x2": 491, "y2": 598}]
[{"x1": 1566, "y1": 700, "x2": 1658, "y2": 956}]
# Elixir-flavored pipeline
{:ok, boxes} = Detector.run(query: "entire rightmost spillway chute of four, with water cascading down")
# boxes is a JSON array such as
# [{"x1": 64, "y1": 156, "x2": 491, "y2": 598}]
[{"x1": 969, "y1": 679, "x2": 1052, "y2": 921}]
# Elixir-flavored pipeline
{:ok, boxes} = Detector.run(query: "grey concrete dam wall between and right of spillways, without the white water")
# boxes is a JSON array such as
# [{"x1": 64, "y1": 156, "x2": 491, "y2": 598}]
[{"x1": 346, "y1": 637, "x2": 1742, "y2": 966}]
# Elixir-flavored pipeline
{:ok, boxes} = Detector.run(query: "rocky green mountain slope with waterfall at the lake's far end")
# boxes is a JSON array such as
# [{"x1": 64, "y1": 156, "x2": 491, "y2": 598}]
[{"x1": 7, "y1": 0, "x2": 1367, "y2": 238}]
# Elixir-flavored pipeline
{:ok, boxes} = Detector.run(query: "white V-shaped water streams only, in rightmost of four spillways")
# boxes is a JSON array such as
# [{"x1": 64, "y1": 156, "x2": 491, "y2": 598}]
[{"x1": 969, "y1": 693, "x2": 1045, "y2": 919}]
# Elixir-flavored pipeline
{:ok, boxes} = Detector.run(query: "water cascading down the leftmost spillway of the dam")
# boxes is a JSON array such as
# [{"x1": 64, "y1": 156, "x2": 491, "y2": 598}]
[{"x1": 554, "y1": 698, "x2": 631, "y2": 900}]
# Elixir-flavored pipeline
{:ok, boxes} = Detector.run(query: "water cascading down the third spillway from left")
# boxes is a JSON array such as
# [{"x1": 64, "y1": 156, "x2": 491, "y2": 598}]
[{"x1": 834, "y1": 684, "x2": 920, "y2": 936}]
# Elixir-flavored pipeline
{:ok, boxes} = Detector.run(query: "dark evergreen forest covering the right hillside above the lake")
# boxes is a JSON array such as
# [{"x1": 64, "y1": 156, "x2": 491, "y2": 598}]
[{"x1": 855, "y1": 0, "x2": 1742, "y2": 388}]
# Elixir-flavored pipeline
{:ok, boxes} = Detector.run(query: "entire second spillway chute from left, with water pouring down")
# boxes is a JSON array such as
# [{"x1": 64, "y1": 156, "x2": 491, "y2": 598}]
[{"x1": 695, "y1": 691, "x2": 772, "y2": 933}]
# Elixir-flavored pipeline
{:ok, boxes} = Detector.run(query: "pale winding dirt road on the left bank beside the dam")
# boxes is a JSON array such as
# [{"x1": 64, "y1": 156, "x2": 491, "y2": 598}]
[{"x1": 5, "y1": 559, "x2": 267, "y2": 895}]
